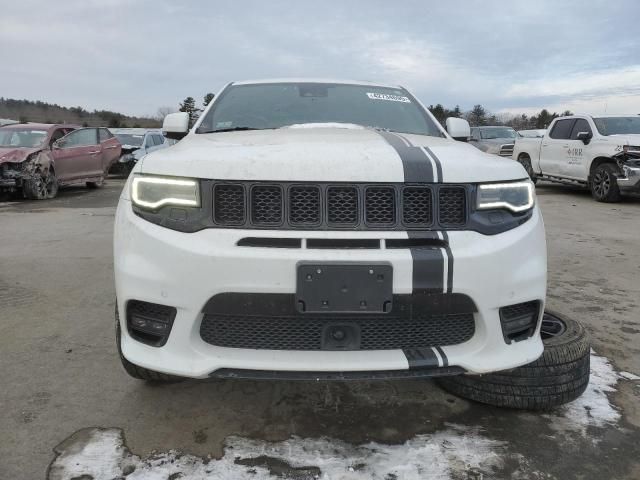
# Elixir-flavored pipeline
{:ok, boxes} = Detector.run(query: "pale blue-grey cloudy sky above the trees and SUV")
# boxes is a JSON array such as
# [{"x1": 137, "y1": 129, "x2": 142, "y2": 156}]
[{"x1": 0, "y1": 0, "x2": 640, "y2": 115}]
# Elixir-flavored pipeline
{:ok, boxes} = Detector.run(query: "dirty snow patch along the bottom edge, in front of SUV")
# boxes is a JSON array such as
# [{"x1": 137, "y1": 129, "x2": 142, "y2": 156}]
[{"x1": 49, "y1": 425, "x2": 539, "y2": 480}]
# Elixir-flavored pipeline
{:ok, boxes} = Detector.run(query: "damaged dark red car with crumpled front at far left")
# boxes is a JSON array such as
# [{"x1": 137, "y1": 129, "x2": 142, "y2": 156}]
[{"x1": 0, "y1": 123, "x2": 121, "y2": 200}]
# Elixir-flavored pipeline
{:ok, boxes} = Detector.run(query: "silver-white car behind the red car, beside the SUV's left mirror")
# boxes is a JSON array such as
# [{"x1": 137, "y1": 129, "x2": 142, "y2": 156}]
[{"x1": 110, "y1": 128, "x2": 172, "y2": 175}]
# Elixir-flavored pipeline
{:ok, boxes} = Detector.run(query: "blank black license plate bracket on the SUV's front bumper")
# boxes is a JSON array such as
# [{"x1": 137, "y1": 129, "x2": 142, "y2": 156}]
[{"x1": 296, "y1": 263, "x2": 393, "y2": 313}]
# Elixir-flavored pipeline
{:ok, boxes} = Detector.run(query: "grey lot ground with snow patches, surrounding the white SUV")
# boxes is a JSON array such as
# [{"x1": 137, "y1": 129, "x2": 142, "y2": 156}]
[{"x1": 0, "y1": 178, "x2": 640, "y2": 480}]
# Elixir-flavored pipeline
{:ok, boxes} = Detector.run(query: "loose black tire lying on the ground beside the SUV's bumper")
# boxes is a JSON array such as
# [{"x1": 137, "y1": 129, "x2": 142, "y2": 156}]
[{"x1": 438, "y1": 312, "x2": 591, "y2": 410}]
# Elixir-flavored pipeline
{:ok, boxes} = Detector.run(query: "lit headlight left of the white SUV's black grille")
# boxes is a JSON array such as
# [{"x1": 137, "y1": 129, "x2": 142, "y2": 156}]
[{"x1": 131, "y1": 175, "x2": 200, "y2": 210}]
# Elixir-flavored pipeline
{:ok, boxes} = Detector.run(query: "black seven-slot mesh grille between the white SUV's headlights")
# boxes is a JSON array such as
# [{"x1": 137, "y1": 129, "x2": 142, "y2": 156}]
[{"x1": 213, "y1": 182, "x2": 468, "y2": 230}]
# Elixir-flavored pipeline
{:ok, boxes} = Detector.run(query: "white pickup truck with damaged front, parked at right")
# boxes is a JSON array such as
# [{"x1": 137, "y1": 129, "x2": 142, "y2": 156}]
[{"x1": 512, "y1": 115, "x2": 640, "y2": 202}]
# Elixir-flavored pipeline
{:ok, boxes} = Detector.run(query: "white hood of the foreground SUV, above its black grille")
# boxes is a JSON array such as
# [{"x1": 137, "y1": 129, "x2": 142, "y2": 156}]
[{"x1": 141, "y1": 126, "x2": 526, "y2": 183}]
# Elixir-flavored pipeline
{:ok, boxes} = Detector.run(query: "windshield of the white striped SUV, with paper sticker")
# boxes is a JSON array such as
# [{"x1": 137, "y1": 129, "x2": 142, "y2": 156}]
[{"x1": 198, "y1": 83, "x2": 442, "y2": 136}]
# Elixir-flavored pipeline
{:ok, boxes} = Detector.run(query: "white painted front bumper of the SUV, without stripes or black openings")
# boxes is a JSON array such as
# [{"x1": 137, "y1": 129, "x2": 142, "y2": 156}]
[{"x1": 114, "y1": 199, "x2": 546, "y2": 378}]
